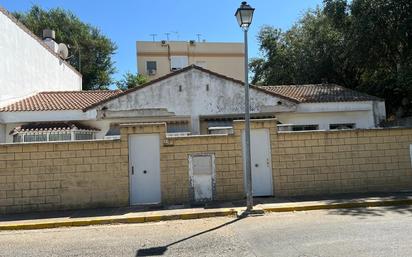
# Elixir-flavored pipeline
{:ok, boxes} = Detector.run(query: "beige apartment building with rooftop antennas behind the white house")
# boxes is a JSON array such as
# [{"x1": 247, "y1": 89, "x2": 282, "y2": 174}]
[{"x1": 136, "y1": 40, "x2": 245, "y2": 81}]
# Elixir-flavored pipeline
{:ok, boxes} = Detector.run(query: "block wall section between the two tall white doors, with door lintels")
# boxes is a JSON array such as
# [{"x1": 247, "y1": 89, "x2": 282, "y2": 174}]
[{"x1": 121, "y1": 120, "x2": 276, "y2": 204}]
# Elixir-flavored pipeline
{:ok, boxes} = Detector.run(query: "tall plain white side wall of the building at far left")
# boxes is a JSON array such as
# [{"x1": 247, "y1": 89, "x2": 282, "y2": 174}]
[{"x1": 0, "y1": 6, "x2": 82, "y2": 107}]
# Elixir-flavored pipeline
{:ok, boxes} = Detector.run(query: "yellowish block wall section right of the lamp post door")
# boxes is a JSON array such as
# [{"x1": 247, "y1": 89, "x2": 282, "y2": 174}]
[{"x1": 272, "y1": 125, "x2": 412, "y2": 196}]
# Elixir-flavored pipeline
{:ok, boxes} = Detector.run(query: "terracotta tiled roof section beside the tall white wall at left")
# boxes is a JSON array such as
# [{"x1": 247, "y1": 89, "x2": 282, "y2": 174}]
[{"x1": 0, "y1": 90, "x2": 122, "y2": 112}]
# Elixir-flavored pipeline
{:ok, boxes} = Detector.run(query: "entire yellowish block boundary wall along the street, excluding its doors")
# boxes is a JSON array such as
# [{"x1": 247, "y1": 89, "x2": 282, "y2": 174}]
[{"x1": 0, "y1": 120, "x2": 412, "y2": 214}]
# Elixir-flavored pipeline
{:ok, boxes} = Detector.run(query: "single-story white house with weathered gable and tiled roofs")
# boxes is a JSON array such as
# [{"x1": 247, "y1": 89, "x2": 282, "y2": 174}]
[{"x1": 0, "y1": 66, "x2": 385, "y2": 143}]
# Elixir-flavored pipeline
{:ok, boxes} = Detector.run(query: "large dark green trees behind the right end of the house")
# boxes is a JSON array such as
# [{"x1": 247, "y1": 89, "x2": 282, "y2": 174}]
[{"x1": 251, "y1": 0, "x2": 412, "y2": 117}]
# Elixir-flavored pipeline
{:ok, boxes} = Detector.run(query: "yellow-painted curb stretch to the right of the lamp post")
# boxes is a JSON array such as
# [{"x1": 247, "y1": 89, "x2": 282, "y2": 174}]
[{"x1": 263, "y1": 199, "x2": 412, "y2": 212}]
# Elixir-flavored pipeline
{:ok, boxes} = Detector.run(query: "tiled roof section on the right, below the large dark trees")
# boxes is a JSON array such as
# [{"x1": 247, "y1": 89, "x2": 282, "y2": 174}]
[{"x1": 259, "y1": 84, "x2": 382, "y2": 103}]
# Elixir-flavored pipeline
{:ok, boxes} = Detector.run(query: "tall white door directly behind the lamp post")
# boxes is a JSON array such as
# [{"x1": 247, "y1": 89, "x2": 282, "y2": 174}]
[{"x1": 243, "y1": 129, "x2": 273, "y2": 196}]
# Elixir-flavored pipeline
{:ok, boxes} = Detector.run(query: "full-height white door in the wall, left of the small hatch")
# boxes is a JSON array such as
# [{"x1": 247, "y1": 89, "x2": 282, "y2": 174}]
[{"x1": 129, "y1": 134, "x2": 161, "y2": 205}]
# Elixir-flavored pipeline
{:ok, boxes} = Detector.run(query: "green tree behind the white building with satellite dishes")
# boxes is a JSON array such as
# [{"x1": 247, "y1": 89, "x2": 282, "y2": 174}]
[{"x1": 13, "y1": 5, "x2": 117, "y2": 90}]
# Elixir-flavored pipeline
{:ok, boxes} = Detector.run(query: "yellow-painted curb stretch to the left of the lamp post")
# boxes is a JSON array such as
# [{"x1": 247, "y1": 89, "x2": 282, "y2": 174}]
[{"x1": 0, "y1": 209, "x2": 237, "y2": 231}]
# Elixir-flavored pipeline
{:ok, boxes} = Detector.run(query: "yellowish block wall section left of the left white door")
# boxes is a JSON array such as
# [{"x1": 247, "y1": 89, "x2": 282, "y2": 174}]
[{"x1": 0, "y1": 140, "x2": 129, "y2": 214}]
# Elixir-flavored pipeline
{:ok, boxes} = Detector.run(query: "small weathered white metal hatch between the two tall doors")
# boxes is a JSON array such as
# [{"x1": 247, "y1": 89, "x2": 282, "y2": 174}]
[{"x1": 189, "y1": 154, "x2": 215, "y2": 202}]
